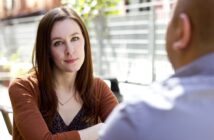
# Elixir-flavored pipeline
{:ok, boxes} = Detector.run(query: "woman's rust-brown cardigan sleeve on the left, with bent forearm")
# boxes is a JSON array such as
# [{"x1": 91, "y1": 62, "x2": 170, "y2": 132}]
[{"x1": 9, "y1": 79, "x2": 80, "y2": 140}]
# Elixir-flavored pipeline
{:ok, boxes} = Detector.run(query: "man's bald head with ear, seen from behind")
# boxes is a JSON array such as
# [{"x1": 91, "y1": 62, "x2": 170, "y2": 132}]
[{"x1": 166, "y1": 0, "x2": 214, "y2": 69}]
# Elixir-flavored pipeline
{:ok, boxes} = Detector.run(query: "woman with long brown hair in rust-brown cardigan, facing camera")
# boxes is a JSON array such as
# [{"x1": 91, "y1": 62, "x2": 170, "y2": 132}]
[{"x1": 9, "y1": 7, "x2": 118, "y2": 140}]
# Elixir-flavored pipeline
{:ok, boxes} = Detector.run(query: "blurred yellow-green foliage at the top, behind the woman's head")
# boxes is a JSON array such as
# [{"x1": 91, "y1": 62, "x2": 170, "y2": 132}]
[{"x1": 61, "y1": 0, "x2": 121, "y2": 21}]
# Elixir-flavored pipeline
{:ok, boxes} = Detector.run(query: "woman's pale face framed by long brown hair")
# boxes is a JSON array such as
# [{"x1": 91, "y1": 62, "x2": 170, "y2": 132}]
[{"x1": 50, "y1": 19, "x2": 85, "y2": 72}]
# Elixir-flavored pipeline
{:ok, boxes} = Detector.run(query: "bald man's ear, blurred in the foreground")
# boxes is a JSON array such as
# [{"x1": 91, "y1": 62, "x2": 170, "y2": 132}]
[{"x1": 173, "y1": 13, "x2": 191, "y2": 50}]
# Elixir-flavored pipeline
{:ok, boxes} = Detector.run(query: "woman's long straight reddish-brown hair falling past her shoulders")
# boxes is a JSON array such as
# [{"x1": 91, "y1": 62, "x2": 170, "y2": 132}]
[{"x1": 32, "y1": 6, "x2": 96, "y2": 127}]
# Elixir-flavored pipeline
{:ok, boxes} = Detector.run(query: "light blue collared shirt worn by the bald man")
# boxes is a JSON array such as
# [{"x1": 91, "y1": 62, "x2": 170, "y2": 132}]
[{"x1": 100, "y1": 53, "x2": 214, "y2": 140}]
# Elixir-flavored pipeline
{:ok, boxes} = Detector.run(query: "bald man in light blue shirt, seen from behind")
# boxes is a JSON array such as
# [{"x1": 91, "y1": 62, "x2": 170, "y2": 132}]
[{"x1": 100, "y1": 0, "x2": 214, "y2": 140}]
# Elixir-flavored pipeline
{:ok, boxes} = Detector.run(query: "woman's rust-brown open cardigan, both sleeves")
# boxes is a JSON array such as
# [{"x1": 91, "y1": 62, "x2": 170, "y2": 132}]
[{"x1": 9, "y1": 76, "x2": 118, "y2": 140}]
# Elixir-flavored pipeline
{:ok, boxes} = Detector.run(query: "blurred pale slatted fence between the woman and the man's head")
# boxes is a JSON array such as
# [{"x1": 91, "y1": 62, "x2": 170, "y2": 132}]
[{"x1": 90, "y1": 0, "x2": 174, "y2": 84}]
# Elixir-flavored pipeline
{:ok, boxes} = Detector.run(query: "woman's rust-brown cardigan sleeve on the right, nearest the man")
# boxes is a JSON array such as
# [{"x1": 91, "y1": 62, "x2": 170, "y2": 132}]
[{"x1": 95, "y1": 78, "x2": 118, "y2": 122}]
